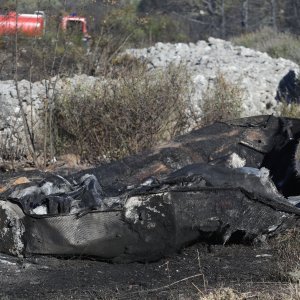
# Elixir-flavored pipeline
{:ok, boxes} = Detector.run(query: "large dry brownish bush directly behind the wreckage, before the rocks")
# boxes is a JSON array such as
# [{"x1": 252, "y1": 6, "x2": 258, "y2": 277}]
[{"x1": 56, "y1": 66, "x2": 189, "y2": 161}]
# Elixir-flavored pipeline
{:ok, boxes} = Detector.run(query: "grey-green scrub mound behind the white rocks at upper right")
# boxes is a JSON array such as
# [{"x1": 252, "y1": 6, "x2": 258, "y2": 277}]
[{"x1": 232, "y1": 27, "x2": 300, "y2": 64}]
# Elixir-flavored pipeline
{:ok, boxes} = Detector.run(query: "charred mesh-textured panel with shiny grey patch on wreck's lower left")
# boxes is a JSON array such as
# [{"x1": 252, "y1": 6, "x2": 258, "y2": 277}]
[{"x1": 25, "y1": 212, "x2": 135, "y2": 259}]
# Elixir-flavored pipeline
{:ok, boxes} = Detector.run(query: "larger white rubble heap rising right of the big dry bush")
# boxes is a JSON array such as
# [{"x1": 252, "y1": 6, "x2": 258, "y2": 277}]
[{"x1": 126, "y1": 38, "x2": 299, "y2": 116}]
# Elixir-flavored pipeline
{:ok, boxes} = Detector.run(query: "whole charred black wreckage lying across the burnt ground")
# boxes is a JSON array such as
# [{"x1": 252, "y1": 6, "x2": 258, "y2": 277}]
[{"x1": 0, "y1": 116, "x2": 300, "y2": 262}]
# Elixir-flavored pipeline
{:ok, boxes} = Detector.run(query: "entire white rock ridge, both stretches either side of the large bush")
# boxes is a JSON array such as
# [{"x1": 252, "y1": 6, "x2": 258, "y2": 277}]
[{"x1": 0, "y1": 38, "x2": 299, "y2": 157}]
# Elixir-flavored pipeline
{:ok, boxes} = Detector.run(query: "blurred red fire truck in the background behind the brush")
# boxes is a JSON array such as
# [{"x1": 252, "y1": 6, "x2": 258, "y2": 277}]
[{"x1": 0, "y1": 11, "x2": 89, "y2": 38}]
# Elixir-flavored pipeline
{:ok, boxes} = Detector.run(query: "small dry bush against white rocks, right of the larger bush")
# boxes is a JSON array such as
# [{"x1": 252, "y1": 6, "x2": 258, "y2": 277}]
[{"x1": 200, "y1": 73, "x2": 244, "y2": 125}]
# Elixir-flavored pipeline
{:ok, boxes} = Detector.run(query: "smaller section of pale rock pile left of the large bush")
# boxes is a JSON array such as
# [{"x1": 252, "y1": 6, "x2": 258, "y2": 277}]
[{"x1": 0, "y1": 74, "x2": 100, "y2": 159}]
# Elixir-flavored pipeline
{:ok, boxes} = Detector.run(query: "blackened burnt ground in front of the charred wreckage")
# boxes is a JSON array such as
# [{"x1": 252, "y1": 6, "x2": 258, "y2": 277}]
[{"x1": 0, "y1": 244, "x2": 282, "y2": 299}]
